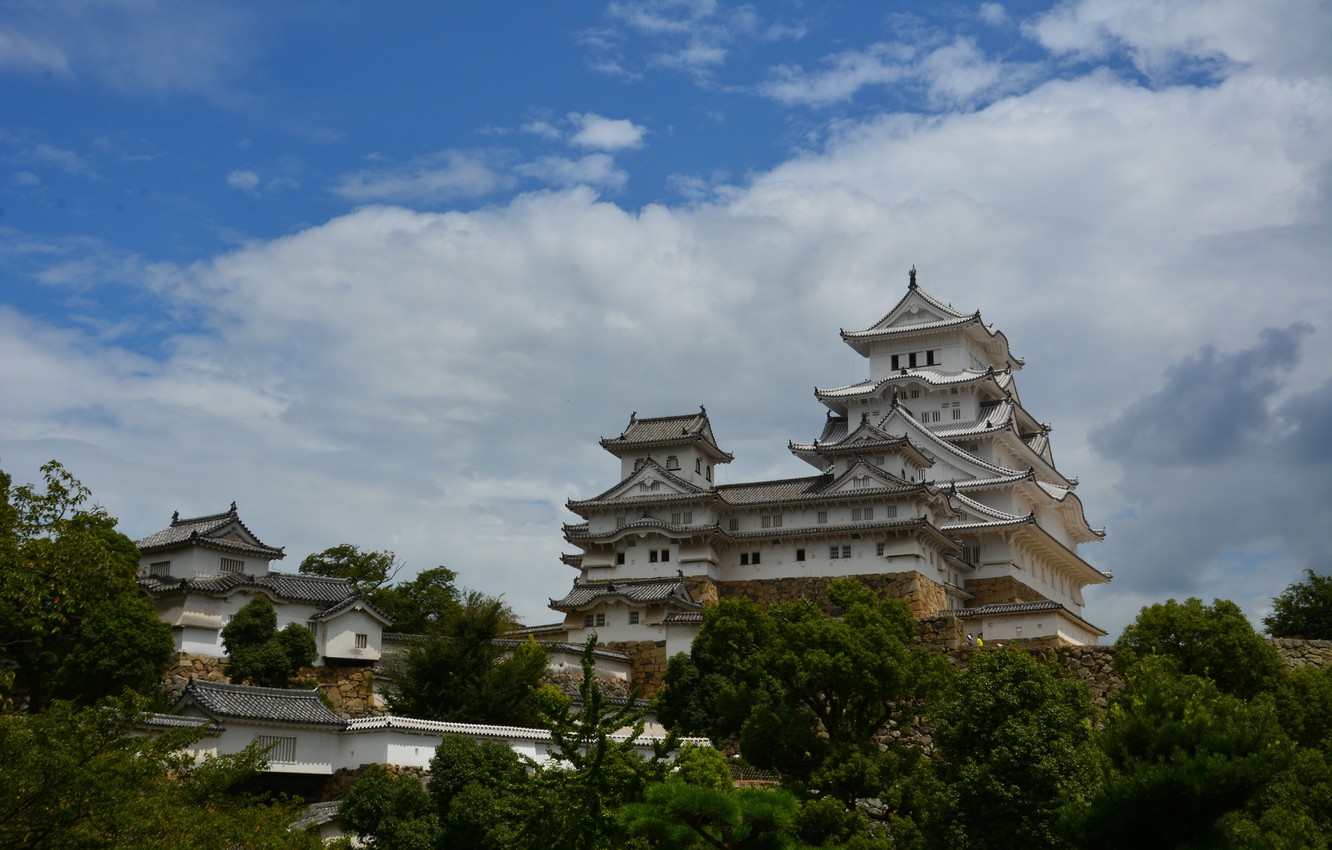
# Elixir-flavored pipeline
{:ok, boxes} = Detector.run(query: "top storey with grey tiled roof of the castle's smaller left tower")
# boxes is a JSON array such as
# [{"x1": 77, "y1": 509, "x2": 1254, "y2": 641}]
[{"x1": 601, "y1": 406, "x2": 734, "y2": 488}]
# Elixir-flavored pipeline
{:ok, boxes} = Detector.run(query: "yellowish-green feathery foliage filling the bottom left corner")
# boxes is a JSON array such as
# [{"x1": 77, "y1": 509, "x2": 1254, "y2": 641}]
[{"x1": 0, "y1": 698, "x2": 320, "y2": 850}]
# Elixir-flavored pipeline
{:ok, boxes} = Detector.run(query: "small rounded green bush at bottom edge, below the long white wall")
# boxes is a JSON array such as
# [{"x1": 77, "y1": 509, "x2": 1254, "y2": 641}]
[{"x1": 338, "y1": 765, "x2": 442, "y2": 850}]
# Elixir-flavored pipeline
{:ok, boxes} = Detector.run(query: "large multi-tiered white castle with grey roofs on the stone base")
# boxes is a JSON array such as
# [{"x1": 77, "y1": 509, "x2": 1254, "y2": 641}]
[{"x1": 527, "y1": 268, "x2": 1110, "y2": 663}]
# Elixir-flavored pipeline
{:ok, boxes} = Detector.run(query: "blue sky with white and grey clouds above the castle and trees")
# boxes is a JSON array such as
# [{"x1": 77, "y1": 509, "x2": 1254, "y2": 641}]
[{"x1": 0, "y1": 0, "x2": 1332, "y2": 638}]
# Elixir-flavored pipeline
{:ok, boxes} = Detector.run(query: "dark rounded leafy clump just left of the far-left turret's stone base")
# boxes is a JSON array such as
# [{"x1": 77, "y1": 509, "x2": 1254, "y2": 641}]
[{"x1": 56, "y1": 593, "x2": 176, "y2": 705}]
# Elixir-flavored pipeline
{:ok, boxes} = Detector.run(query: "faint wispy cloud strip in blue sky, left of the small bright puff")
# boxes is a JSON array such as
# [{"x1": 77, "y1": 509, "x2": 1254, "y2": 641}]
[{"x1": 333, "y1": 151, "x2": 513, "y2": 203}]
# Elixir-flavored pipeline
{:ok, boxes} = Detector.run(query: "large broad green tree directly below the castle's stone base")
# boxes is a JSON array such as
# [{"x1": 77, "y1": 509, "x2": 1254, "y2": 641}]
[{"x1": 661, "y1": 580, "x2": 947, "y2": 805}]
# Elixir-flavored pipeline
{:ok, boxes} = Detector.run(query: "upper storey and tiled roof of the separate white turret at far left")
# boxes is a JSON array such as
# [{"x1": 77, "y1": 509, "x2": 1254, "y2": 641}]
[{"x1": 136, "y1": 502, "x2": 286, "y2": 578}]
